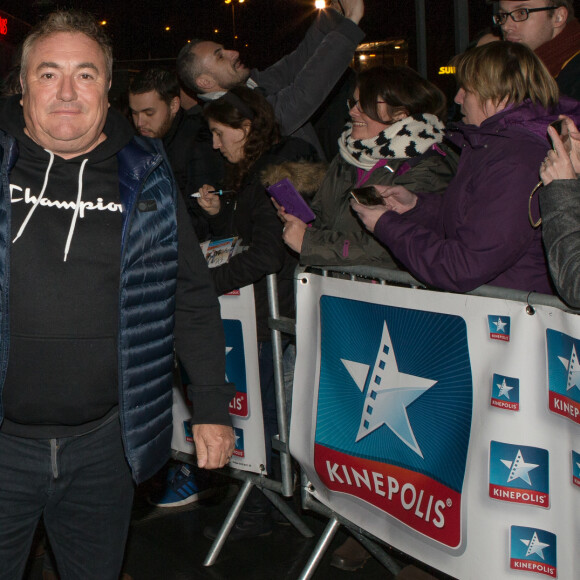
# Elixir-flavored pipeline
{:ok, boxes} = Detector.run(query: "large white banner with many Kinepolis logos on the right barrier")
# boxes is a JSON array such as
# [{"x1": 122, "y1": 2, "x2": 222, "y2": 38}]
[{"x1": 290, "y1": 274, "x2": 580, "y2": 580}]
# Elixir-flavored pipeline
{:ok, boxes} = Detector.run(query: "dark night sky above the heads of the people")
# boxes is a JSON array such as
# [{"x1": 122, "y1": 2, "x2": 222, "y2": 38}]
[{"x1": 0, "y1": 0, "x2": 580, "y2": 80}]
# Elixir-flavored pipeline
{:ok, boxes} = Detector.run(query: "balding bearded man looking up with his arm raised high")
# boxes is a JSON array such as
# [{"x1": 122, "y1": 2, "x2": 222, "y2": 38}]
[{"x1": 177, "y1": 0, "x2": 364, "y2": 158}]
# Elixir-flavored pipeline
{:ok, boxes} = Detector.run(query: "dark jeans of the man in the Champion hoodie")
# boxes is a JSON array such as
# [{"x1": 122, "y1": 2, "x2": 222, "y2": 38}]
[{"x1": 0, "y1": 417, "x2": 134, "y2": 580}]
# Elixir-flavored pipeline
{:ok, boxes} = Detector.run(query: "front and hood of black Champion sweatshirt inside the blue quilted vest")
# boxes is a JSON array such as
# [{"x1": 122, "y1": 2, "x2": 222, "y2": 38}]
[{"x1": 0, "y1": 97, "x2": 132, "y2": 438}]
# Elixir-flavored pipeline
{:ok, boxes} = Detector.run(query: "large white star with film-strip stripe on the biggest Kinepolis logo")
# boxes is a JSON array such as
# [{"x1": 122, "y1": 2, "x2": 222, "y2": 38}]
[{"x1": 341, "y1": 322, "x2": 437, "y2": 457}]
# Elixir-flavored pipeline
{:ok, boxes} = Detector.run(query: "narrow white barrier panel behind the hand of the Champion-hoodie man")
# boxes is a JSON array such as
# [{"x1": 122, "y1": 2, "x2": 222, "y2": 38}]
[{"x1": 171, "y1": 286, "x2": 266, "y2": 473}]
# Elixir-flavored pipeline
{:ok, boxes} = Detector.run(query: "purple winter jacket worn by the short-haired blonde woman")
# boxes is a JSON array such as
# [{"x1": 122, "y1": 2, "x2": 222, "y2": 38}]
[{"x1": 374, "y1": 98, "x2": 580, "y2": 294}]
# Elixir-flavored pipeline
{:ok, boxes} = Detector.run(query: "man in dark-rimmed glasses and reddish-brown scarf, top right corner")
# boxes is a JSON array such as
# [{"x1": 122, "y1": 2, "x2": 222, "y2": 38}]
[{"x1": 493, "y1": 0, "x2": 580, "y2": 100}]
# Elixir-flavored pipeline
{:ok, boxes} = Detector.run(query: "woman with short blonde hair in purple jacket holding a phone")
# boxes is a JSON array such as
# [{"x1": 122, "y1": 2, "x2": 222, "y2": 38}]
[{"x1": 352, "y1": 42, "x2": 580, "y2": 294}]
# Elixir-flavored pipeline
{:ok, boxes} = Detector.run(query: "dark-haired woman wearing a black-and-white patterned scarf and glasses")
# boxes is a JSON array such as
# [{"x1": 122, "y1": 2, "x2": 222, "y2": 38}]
[{"x1": 279, "y1": 66, "x2": 456, "y2": 267}]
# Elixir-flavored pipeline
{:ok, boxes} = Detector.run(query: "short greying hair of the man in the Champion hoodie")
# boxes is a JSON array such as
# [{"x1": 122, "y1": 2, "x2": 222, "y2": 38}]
[{"x1": 20, "y1": 10, "x2": 113, "y2": 91}]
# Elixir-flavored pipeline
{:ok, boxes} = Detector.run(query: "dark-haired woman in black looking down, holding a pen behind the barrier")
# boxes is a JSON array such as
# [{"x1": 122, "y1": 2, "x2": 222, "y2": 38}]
[{"x1": 197, "y1": 87, "x2": 316, "y2": 539}]
